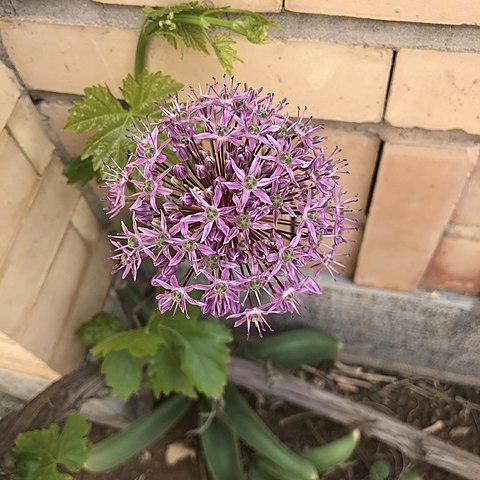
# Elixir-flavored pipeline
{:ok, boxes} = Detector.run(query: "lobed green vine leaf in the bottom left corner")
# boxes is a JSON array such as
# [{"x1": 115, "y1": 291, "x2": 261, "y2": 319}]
[{"x1": 13, "y1": 413, "x2": 90, "y2": 480}]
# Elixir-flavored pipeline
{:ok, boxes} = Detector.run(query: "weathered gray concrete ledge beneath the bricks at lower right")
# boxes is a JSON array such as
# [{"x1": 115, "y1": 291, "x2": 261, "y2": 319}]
[{"x1": 274, "y1": 278, "x2": 480, "y2": 385}]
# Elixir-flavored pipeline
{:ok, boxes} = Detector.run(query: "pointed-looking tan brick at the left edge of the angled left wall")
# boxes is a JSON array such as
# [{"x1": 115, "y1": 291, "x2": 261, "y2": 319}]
[{"x1": 0, "y1": 130, "x2": 40, "y2": 268}]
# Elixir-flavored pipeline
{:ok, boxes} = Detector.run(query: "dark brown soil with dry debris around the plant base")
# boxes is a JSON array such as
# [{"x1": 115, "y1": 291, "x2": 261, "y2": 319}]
[{"x1": 76, "y1": 363, "x2": 480, "y2": 480}]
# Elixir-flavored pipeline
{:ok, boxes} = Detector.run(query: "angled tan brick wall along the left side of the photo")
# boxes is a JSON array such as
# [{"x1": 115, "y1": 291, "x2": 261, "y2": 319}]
[{"x1": 0, "y1": 63, "x2": 111, "y2": 378}]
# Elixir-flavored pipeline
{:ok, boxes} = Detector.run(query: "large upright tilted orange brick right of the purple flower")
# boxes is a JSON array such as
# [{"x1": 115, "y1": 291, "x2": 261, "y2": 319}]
[{"x1": 355, "y1": 144, "x2": 478, "y2": 291}]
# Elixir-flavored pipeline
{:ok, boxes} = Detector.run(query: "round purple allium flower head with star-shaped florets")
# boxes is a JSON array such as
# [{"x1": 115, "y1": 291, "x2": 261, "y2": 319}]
[{"x1": 106, "y1": 79, "x2": 355, "y2": 335}]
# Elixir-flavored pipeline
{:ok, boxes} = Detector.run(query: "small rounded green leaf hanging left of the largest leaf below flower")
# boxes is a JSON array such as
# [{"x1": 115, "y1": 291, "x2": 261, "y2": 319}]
[{"x1": 100, "y1": 350, "x2": 144, "y2": 400}]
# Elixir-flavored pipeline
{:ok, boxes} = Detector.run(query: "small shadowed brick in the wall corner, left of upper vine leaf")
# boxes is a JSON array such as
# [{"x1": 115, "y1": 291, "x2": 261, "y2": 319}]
[{"x1": 38, "y1": 101, "x2": 90, "y2": 157}]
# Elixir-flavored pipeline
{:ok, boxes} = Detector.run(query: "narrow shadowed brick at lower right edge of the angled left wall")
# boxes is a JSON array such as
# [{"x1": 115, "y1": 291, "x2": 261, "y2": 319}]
[{"x1": 48, "y1": 237, "x2": 112, "y2": 374}]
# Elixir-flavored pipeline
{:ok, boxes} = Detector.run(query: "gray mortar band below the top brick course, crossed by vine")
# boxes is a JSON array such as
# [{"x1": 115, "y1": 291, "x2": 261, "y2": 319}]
[{"x1": 0, "y1": 0, "x2": 480, "y2": 52}]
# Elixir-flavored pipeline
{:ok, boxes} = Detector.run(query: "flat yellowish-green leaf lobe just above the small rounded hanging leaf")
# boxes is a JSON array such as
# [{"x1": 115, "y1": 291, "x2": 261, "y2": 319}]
[{"x1": 92, "y1": 328, "x2": 165, "y2": 358}]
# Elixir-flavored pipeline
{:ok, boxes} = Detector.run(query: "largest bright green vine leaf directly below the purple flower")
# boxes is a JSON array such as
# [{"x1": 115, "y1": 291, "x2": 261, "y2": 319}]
[{"x1": 150, "y1": 314, "x2": 232, "y2": 398}]
